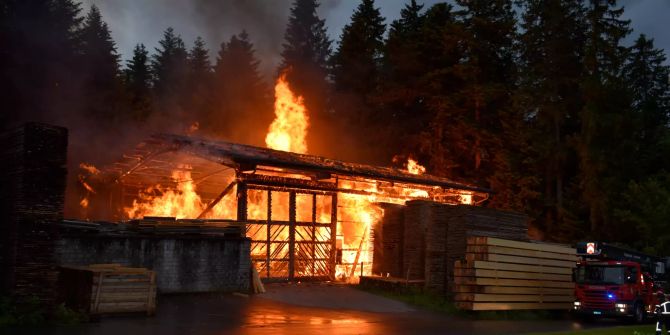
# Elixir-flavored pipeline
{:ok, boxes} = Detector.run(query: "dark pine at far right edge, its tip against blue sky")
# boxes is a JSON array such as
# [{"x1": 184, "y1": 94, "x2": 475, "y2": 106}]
[{"x1": 608, "y1": 35, "x2": 670, "y2": 249}]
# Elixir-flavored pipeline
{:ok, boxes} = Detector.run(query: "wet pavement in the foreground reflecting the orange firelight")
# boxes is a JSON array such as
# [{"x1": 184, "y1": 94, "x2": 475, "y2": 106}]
[{"x1": 7, "y1": 284, "x2": 632, "y2": 335}]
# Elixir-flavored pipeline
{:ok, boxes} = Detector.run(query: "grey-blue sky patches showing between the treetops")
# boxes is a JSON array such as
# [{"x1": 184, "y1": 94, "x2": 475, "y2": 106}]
[{"x1": 83, "y1": 0, "x2": 670, "y2": 74}]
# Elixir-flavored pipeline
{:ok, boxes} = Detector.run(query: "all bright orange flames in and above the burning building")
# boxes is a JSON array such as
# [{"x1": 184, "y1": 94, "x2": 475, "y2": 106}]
[{"x1": 115, "y1": 74, "x2": 462, "y2": 282}]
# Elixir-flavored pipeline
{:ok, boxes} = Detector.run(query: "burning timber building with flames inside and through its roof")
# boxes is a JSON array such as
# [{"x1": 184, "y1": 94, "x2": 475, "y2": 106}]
[{"x1": 80, "y1": 76, "x2": 488, "y2": 281}]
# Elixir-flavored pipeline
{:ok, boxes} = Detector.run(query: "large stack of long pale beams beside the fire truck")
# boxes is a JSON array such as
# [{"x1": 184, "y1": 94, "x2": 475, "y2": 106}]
[{"x1": 452, "y1": 236, "x2": 577, "y2": 311}]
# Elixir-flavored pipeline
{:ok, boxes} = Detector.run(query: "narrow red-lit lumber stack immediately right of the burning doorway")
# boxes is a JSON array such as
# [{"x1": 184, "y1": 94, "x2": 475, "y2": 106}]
[{"x1": 373, "y1": 204, "x2": 405, "y2": 277}]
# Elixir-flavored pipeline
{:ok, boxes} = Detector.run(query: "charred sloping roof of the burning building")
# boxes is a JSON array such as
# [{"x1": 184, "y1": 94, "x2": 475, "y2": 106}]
[{"x1": 110, "y1": 134, "x2": 491, "y2": 195}]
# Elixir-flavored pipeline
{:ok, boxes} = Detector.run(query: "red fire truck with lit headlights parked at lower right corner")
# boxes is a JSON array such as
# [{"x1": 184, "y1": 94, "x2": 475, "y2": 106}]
[{"x1": 573, "y1": 242, "x2": 665, "y2": 322}]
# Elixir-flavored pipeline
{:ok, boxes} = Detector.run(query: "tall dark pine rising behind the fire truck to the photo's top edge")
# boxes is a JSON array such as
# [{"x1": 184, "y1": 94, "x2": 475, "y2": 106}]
[{"x1": 578, "y1": 0, "x2": 634, "y2": 239}]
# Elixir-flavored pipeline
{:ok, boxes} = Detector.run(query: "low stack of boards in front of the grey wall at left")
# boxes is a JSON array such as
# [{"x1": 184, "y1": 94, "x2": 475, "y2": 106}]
[{"x1": 59, "y1": 264, "x2": 156, "y2": 315}]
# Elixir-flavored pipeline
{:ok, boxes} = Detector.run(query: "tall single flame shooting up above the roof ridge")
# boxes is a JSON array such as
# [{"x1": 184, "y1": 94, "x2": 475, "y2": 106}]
[{"x1": 265, "y1": 73, "x2": 309, "y2": 154}]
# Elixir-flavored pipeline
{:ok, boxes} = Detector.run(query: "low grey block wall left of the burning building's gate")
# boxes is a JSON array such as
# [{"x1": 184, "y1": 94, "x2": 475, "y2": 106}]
[{"x1": 55, "y1": 234, "x2": 251, "y2": 293}]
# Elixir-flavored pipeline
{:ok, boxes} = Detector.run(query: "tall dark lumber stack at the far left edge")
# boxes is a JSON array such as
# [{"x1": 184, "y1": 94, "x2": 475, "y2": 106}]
[{"x1": 0, "y1": 123, "x2": 67, "y2": 304}]
